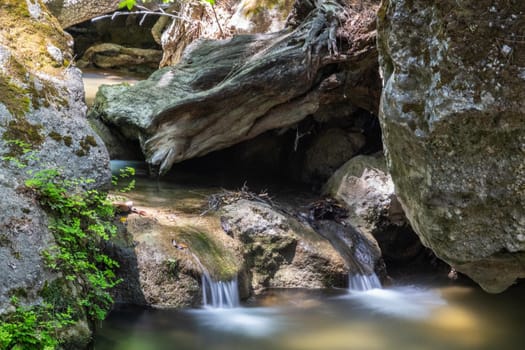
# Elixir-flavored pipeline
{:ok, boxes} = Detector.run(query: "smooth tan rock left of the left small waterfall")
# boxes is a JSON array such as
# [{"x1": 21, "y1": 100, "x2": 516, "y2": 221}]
[{"x1": 111, "y1": 203, "x2": 243, "y2": 307}]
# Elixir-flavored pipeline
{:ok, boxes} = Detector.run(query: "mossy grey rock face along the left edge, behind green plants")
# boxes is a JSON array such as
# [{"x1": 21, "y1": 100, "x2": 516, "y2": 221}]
[{"x1": 0, "y1": 0, "x2": 110, "y2": 345}]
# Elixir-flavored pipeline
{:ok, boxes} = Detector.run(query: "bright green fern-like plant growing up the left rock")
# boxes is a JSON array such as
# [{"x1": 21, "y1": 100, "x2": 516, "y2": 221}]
[{"x1": 26, "y1": 169, "x2": 120, "y2": 320}]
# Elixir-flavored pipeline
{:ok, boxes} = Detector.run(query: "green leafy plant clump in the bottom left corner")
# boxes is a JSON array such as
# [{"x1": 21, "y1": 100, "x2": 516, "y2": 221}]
[{"x1": 0, "y1": 297, "x2": 74, "y2": 350}]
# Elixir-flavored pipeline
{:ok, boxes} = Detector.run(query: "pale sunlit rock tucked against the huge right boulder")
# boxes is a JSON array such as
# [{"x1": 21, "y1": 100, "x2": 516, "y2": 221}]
[{"x1": 323, "y1": 154, "x2": 424, "y2": 262}]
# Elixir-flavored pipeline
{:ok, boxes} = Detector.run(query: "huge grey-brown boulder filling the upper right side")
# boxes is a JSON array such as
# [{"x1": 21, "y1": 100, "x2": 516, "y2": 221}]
[{"x1": 378, "y1": 0, "x2": 525, "y2": 292}]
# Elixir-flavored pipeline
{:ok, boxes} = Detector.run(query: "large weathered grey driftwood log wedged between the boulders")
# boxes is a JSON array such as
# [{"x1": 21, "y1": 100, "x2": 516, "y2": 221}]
[{"x1": 90, "y1": 0, "x2": 380, "y2": 174}]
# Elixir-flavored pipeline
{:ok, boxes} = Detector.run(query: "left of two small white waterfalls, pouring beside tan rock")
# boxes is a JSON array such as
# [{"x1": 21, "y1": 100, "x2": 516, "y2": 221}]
[{"x1": 202, "y1": 271, "x2": 239, "y2": 309}]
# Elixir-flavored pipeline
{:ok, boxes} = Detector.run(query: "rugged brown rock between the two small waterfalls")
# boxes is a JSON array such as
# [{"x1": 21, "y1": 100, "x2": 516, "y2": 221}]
[{"x1": 221, "y1": 199, "x2": 348, "y2": 292}]
